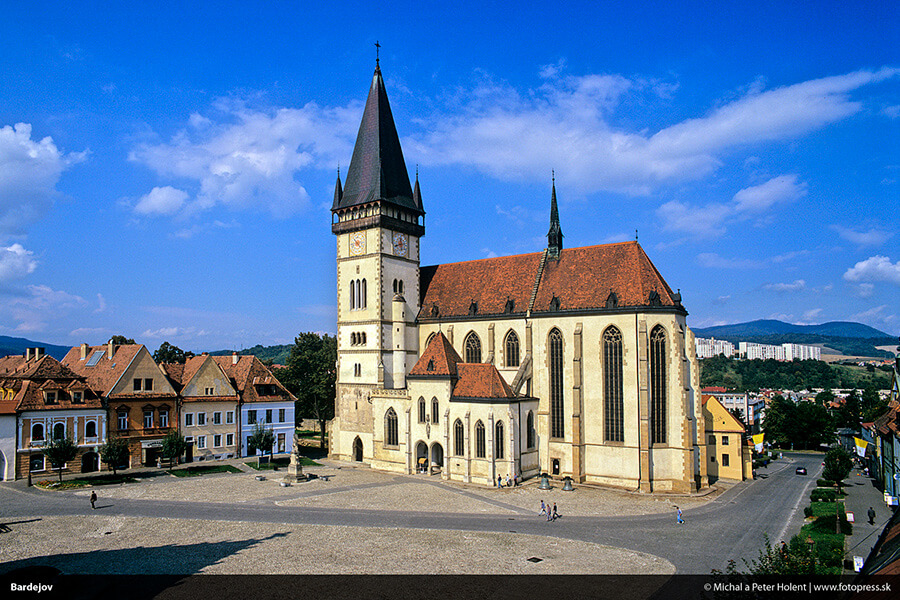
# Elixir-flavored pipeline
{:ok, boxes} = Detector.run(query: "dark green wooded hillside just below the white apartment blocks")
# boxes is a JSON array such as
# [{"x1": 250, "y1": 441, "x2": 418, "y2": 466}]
[{"x1": 700, "y1": 356, "x2": 890, "y2": 392}]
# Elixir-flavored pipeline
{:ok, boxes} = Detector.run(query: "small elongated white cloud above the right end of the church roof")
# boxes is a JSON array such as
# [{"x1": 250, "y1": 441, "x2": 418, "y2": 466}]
[{"x1": 656, "y1": 175, "x2": 806, "y2": 238}]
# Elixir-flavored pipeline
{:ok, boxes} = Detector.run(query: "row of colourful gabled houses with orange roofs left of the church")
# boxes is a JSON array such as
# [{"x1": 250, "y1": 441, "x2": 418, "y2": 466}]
[{"x1": 0, "y1": 342, "x2": 296, "y2": 481}]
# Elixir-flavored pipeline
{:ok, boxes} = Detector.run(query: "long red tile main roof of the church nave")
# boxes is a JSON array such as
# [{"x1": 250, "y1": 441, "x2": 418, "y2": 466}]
[{"x1": 419, "y1": 242, "x2": 684, "y2": 321}]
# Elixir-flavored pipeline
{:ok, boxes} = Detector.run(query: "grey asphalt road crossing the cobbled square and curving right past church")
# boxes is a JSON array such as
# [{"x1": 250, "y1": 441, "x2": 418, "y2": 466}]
[{"x1": 0, "y1": 454, "x2": 822, "y2": 574}]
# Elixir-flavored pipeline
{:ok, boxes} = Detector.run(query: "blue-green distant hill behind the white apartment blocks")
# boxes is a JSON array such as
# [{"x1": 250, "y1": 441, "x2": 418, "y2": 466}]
[{"x1": 694, "y1": 320, "x2": 897, "y2": 358}]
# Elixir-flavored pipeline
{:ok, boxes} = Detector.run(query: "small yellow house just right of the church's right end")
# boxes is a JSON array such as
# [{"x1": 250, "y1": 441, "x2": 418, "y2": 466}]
[{"x1": 703, "y1": 395, "x2": 753, "y2": 482}]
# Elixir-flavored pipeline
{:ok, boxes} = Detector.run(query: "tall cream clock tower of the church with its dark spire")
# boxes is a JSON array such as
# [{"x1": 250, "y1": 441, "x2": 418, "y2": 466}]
[{"x1": 331, "y1": 61, "x2": 425, "y2": 460}]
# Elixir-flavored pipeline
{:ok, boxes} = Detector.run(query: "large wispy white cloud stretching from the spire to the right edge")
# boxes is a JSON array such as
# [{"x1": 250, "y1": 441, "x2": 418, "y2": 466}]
[{"x1": 404, "y1": 65, "x2": 900, "y2": 195}]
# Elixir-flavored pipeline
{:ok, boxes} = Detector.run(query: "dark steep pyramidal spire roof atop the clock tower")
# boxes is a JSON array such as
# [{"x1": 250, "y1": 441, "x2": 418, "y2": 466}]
[{"x1": 331, "y1": 61, "x2": 424, "y2": 213}]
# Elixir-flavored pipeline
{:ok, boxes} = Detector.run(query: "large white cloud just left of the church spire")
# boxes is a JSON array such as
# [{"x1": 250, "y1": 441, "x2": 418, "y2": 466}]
[{"x1": 129, "y1": 100, "x2": 360, "y2": 218}]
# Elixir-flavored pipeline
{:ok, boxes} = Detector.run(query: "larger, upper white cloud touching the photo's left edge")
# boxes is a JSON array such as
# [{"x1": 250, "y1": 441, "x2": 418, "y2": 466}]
[{"x1": 0, "y1": 123, "x2": 87, "y2": 235}]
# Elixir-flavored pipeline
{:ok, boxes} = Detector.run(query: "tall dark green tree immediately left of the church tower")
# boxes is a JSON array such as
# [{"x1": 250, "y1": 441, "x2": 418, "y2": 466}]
[{"x1": 275, "y1": 332, "x2": 337, "y2": 448}]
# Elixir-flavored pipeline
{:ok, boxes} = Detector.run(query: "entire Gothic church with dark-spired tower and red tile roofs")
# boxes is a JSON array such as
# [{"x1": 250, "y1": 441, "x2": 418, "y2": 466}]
[{"x1": 329, "y1": 61, "x2": 708, "y2": 493}]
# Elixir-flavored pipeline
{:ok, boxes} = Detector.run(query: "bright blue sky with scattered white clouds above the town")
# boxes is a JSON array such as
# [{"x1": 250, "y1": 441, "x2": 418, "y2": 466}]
[{"x1": 0, "y1": 1, "x2": 900, "y2": 351}]
